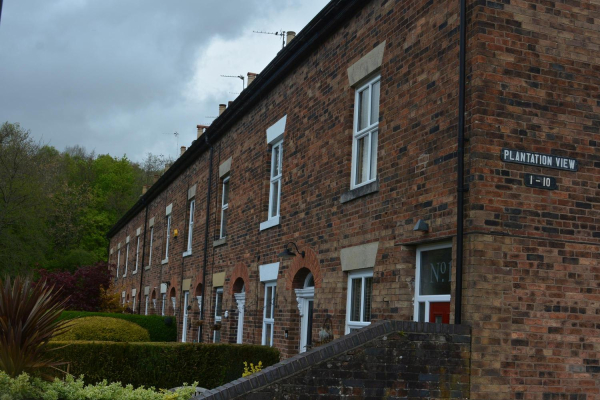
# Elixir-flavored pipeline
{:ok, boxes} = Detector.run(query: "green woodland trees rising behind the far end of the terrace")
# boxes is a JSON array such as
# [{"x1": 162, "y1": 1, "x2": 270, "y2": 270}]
[{"x1": 0, "y1": 122, "x2": 172, "y2": 276}]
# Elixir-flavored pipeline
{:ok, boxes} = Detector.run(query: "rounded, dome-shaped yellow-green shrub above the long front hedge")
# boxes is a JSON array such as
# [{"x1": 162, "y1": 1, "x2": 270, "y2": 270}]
[{"x1": 53, "y1": 317, "x2": 150, "y2": 342}]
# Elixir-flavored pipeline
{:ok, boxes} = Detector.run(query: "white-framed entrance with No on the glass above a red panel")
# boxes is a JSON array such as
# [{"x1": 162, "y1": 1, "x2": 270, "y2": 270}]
[{"x1": 414, "y1": 243, "x2": 452, "y2": 324}]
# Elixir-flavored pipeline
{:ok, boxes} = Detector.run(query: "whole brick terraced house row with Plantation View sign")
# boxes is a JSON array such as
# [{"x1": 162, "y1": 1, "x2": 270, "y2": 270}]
[{"x1": 108, "y1": 0, "x2": 600, "y2": 400}]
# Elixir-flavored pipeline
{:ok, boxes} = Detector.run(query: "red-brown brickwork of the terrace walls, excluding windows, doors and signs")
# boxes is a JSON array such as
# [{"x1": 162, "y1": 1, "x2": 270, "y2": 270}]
[{"x1": 111, "y1": 0, "x2": 600, "y2": 400}]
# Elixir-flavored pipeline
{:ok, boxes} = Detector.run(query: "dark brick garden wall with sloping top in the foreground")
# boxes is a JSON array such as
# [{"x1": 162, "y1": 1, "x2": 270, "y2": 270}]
[{"x1": 196, "y1": 321, "x2": 471, "y2": 400}]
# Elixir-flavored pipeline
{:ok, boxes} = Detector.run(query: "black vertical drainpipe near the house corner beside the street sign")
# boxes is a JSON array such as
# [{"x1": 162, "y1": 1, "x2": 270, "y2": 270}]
[{"x1": 454, "y1": 0, "x2": 468, "y2": 325}]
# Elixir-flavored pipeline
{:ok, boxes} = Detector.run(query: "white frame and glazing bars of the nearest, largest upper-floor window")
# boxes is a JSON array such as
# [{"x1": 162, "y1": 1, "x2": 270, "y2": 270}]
[{"x1": 350, "y1": 75, "x2": 381, "y2": 189}]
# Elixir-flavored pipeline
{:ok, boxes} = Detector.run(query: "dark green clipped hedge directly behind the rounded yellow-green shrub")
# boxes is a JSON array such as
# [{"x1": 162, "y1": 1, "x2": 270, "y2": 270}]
[{"x1": 60, "y1": 311, "x2": 177, "y2": 342}]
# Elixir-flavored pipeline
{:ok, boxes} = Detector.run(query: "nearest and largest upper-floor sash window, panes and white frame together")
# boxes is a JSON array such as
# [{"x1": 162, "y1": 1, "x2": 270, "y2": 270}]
[{"x1": 352, "y1": 76, "x2": 381, "y2": 187}]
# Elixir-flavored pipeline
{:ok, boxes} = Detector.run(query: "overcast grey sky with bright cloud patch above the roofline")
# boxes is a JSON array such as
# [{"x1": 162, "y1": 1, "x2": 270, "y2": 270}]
[{"x1": 0, "y1": 0, "x2": 328, "y2": 161}]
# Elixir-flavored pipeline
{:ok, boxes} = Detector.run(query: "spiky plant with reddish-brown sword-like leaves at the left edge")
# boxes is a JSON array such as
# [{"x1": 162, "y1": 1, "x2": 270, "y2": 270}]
[{"x1": 0, "y1": 277, "x2": 68, "y2": 379}]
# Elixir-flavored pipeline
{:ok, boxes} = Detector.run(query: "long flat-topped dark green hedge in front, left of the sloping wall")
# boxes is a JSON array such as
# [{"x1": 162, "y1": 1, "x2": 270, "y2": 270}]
[{"x1": 50, "y1": 342, "x2": 279, "y2": 389}]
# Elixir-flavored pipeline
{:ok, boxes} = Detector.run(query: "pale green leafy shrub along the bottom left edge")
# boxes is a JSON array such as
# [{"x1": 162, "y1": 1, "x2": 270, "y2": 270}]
[{"x1": 0, "y1": 371, "x2": 196, "y2": 400}]
